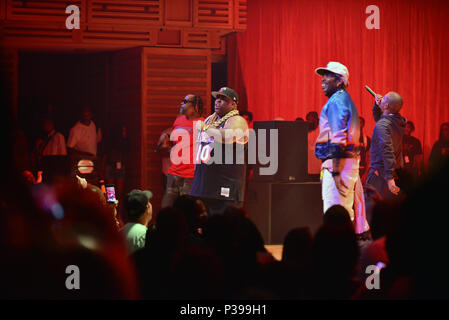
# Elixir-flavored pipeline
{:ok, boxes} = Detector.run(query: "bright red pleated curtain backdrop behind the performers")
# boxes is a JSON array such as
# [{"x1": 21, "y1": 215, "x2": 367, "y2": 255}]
[{"x1": 228, "y1": 0, "x2": 449, "y2": 158}]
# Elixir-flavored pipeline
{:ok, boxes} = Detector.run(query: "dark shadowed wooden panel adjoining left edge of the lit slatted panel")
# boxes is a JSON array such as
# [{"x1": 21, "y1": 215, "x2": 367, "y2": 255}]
[{"x1": 109, "y1": 48, "x2": 143, "y2": 195}]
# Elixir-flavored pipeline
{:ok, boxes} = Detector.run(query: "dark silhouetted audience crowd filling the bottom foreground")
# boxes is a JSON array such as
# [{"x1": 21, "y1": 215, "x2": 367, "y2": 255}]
[{"x1": 0, "y1": 155, "x2": 449, "y2": 300}]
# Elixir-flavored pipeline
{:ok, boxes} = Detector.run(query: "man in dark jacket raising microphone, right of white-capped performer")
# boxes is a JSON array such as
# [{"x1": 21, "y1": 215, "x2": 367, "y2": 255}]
[{"x1": 367, "y1": 92, "x2": 406, "y2": 199}]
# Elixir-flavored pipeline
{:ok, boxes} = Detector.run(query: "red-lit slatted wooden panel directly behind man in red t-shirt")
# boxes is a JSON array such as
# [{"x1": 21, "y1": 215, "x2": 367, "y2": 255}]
[{"x1": 142, "y1": 48, "x2": 211, "y2": 205}]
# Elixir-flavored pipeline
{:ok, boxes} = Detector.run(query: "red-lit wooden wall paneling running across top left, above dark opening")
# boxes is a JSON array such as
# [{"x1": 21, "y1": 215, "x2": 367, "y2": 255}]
[{"x1": 0, "y1": 0, "x2": 247, "y2": 50}]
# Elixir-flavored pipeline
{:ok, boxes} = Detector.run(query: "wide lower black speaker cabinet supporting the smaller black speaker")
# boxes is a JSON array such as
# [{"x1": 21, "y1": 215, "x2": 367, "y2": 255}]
[{"x1": 248, "y1": 182, "x2": 323, "y2": 244}]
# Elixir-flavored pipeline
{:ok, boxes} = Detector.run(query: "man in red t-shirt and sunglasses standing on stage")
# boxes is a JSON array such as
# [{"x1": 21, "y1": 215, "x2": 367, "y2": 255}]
[{"x1": 162, "y1": 94, "x2": 204, "y2": 208}]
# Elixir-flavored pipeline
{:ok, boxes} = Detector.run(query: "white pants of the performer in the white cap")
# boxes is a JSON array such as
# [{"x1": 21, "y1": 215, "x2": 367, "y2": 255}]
[{"x1": 321, "y1": 158, "x2": 363, "y2": 221}]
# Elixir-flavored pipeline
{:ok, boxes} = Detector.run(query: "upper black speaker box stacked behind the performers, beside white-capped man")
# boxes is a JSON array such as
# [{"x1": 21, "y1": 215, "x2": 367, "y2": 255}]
[{"x1": 254, "y1": 121, "x2": 310, "y2": 182}]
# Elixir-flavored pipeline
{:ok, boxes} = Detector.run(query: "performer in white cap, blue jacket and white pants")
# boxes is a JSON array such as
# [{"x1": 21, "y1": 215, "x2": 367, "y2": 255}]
[{"x1": 315, "y1": 62, "x2": 369, "y2": 234}]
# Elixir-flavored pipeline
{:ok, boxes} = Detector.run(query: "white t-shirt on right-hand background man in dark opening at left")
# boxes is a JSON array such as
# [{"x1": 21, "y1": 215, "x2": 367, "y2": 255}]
[{"x1": 67, "y1": 121, "x2": 101, "y2": 156}]
